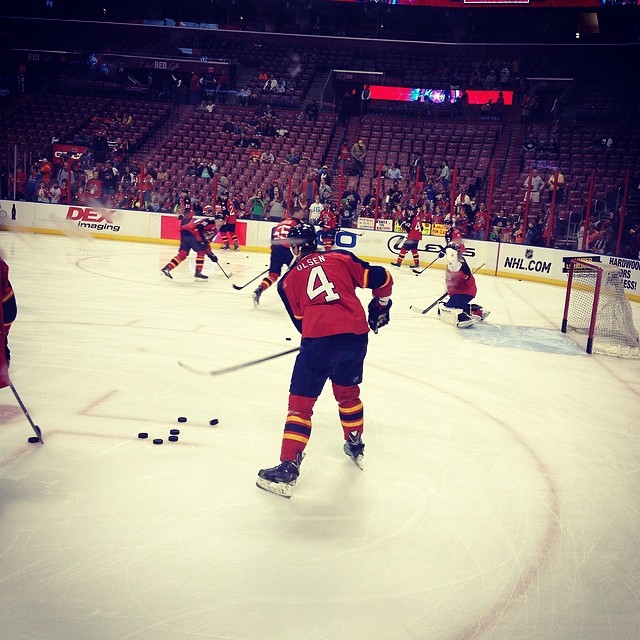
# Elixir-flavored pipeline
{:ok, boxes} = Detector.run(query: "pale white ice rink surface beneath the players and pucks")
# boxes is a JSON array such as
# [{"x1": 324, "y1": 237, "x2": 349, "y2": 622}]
[{"x1": 0, "y1": 233, "x2": 640, "y2": 640}]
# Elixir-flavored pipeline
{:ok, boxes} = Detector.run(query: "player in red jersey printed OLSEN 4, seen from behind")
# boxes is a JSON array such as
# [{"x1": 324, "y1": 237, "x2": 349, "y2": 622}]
[{"x1": 256, "y1": 223, "x2": 393, "y2": 498}]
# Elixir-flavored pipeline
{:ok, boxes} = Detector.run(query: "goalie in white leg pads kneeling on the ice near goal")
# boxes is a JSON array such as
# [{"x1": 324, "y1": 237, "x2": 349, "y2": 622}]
[{"x1": 438, "y1": 243, "x2": 489, "y2": 329}]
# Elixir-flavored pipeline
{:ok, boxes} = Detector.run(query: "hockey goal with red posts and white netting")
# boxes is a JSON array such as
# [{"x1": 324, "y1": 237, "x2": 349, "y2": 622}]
[{"x1": 562, "y1": 259, "x2": 640, "y2": 358}]
